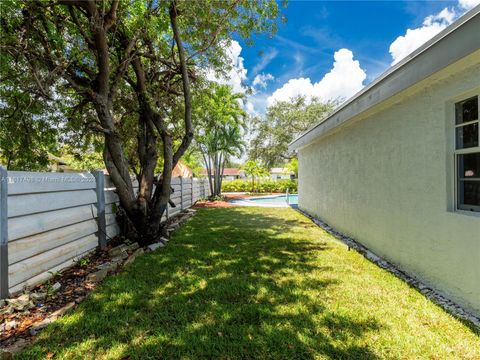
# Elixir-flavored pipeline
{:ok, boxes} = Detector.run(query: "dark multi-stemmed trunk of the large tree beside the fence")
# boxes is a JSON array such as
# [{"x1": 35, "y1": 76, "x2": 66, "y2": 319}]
[{"x1": 111, "y1": 1, "x2": 193, "y2": 245}]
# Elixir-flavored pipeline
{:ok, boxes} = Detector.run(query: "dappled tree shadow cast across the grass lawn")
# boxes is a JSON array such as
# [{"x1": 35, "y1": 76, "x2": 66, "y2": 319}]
[{"x1": 21, "y1": 208, "x2": 381, "y2": 359}]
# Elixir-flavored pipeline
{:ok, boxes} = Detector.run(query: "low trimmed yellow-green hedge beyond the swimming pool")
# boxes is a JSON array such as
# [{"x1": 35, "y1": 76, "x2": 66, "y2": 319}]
[{"x1": 222, "y1": 179, "x2": 297, "y2": 193}]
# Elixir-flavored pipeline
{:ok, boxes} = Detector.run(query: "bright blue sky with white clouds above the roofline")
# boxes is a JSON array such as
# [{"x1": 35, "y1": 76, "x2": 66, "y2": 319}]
[{"x1": 215, "y1": 0, "x2": 480, "y2": 113}]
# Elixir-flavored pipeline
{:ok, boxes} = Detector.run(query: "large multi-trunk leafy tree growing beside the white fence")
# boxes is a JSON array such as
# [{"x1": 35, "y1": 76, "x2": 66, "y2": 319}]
[{"x1": 0, "y1": 0, "x2": 278, "y2": 242}]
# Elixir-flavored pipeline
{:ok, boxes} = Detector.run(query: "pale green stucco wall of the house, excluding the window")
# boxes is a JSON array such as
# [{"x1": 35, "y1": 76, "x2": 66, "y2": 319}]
[{"x1": 298, "y1": 52, "x2": 480, "y2": 315}]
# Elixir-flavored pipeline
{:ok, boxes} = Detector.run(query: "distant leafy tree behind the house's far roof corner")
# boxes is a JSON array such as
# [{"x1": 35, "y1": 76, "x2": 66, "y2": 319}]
[{"x1": 249, "y1": 96, "x2": 335, "y2": 167}]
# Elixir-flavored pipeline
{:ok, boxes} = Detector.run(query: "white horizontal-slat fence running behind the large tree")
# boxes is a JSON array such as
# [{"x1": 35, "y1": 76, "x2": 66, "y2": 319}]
[{"x1": 0, "y1": 167, "x2": 209, "y2": 298}]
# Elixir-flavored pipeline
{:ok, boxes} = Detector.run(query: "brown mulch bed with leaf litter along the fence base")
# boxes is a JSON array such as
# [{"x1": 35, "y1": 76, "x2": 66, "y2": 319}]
[{"x1": 0, "y1": 240, "x2": 124, "y2": 348}]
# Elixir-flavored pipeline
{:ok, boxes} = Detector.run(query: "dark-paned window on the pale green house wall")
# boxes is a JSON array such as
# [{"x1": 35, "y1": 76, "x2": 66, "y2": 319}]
[{"x1": 455, "y1": 96, "x2": 480, "y2": 211}]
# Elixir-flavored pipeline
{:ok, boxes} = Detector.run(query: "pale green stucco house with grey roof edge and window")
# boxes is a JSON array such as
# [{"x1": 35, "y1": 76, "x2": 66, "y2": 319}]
[{"x1": 290, "y1": 6, "x2": 480, "y2": 314}]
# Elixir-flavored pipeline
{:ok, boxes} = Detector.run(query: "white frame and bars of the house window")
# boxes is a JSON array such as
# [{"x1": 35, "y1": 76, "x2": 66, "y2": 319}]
[{"x1": 453, "y1": 93, "x2": 480, "y2": 213}]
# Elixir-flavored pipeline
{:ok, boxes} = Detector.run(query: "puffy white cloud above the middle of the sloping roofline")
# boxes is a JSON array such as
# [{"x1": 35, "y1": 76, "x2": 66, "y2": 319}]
[{"x1": 267, "y1": 49, "x2": 367, "y2": 105}]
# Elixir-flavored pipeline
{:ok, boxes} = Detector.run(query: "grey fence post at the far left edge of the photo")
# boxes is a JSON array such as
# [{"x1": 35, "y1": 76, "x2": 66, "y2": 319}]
[{"x1": 0, "y1": 166, "x2": 8, "y2": 299}]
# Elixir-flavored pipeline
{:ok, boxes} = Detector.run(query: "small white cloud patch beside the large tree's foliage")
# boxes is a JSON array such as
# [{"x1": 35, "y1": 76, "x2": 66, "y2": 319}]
[{"x1": 207, "y1": 40, "x2": 247, "y2": 93}]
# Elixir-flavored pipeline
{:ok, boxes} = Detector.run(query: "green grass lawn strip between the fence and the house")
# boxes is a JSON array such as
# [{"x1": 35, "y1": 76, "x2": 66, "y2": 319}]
[{"x1": 20, "y1": 208, "x2": 480, "y2": 359}]
